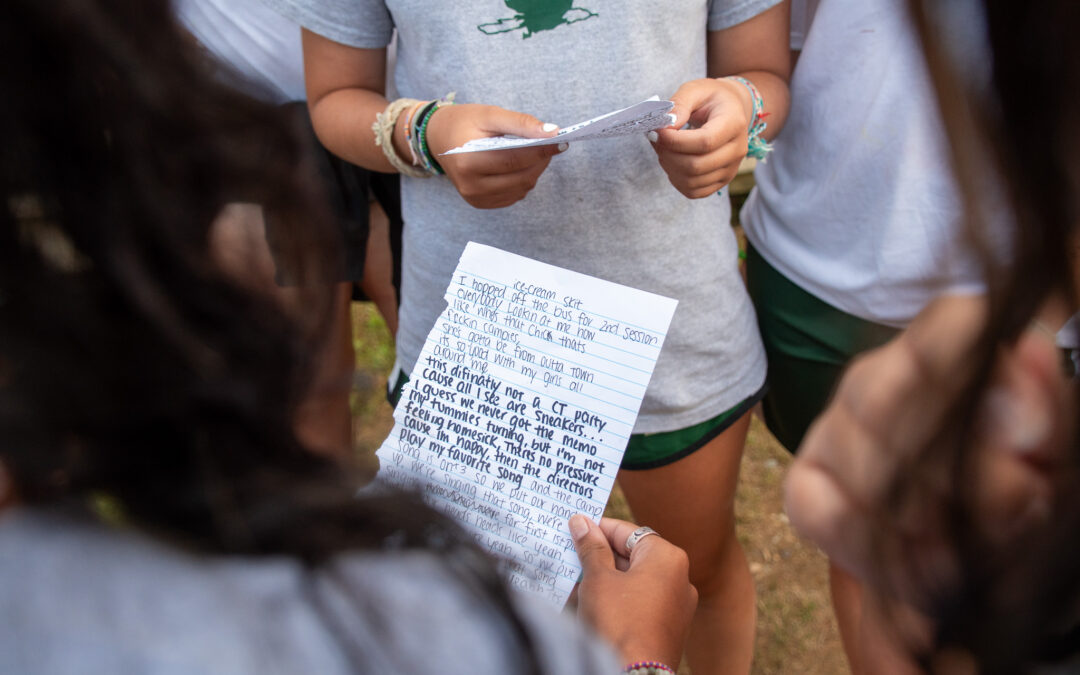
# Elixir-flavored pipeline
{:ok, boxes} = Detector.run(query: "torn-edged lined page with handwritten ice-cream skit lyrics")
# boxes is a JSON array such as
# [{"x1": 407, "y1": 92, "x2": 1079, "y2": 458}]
[{"x1": 377, "y1": 242, "x2": 676, "y2": 607}]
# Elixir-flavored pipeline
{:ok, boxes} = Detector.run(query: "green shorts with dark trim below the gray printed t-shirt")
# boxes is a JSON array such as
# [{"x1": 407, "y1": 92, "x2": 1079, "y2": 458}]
[{"x1": 387, "y1": 373, "x2": 766, "y2": 471}]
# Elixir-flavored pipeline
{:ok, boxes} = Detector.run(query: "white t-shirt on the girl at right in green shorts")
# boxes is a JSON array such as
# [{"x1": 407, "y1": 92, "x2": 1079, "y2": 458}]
[{"x1": 742, "y1": 0, "x2": 983, "y2": 326}]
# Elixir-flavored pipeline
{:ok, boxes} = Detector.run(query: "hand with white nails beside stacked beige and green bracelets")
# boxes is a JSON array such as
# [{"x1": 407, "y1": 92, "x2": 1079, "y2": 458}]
[{"x1": 428, "y1": 104, "x2": 565, "y2": 208}]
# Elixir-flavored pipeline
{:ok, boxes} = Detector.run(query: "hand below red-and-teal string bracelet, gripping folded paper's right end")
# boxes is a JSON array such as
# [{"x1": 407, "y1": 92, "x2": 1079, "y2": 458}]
[{"x1": 649, "y1": 78, "x2": 754, "y2": 199}]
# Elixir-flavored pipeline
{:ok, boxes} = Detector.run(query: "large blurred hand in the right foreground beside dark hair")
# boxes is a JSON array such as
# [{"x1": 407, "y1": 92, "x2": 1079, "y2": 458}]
[{"x1": 785, "y1": 297, "x2": 1075, "y2": 607}]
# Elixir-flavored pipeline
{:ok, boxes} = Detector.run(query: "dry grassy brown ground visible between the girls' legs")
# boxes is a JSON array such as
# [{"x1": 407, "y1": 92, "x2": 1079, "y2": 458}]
[{"x1": 353, "y1": 303, "x2": 849, "y2": 675}]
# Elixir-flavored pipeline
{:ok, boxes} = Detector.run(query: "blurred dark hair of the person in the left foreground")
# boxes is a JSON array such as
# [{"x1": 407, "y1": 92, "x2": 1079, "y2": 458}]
[{"x1": 0, "y1": 0, "x2": 535, "y2": 666}]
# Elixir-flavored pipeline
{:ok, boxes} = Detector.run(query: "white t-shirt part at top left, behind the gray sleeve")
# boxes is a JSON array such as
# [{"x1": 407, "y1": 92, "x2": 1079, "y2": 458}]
[{"x1": 173, "y1": 0, "x2": 307, "y2": 104}]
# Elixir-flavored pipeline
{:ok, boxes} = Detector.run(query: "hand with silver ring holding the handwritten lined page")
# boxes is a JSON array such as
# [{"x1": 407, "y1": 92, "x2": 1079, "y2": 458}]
[{"x1": 570, "y1": 515, "x2": 698, "y2": 667}]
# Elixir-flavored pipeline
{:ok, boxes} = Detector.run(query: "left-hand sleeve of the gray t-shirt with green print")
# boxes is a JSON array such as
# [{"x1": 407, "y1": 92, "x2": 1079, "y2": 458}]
[{"x1": 262, "y1": 0, "x2": 394, "y2": 49}]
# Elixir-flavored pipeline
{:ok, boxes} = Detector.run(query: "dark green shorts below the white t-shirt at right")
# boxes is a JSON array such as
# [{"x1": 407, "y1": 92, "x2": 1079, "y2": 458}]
[{"x1": 746, "y1": 247, "x2": 900, "y2": 453}]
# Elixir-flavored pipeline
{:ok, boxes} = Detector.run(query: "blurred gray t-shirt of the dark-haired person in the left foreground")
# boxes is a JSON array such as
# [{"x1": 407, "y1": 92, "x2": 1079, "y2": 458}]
[{"x1": 0, "y1": 510, "x2": 619, "y2": 675}]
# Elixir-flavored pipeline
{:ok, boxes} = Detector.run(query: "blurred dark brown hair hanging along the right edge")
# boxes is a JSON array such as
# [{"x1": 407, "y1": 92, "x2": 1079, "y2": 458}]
[{"x1": 879, "y1": 0, "x2": 1080, "y2": 674}]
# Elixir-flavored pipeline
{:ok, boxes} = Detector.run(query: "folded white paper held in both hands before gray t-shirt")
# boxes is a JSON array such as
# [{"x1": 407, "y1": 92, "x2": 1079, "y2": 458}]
[{"x1": 443, "y1": 96, "x2": 675, "y2": 154}]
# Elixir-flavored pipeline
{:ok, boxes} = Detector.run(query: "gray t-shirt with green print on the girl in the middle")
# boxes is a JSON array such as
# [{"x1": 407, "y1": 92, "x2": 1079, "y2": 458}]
[{"x1": 265, "y1": 0, "x2": 780, "y2": 433}]
